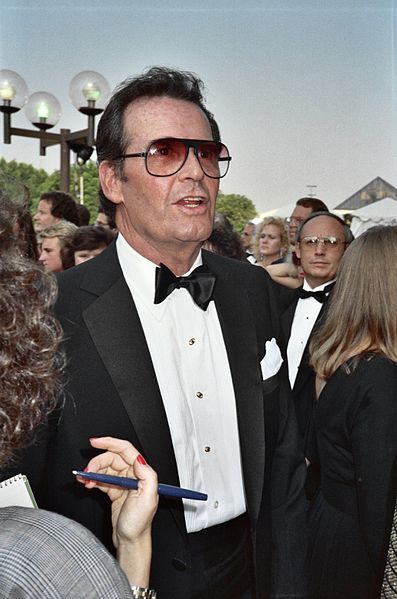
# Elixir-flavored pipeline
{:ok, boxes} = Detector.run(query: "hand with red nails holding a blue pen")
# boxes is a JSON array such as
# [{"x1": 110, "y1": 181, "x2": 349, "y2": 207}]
[{"x1": 77, "y1": 437, "x2": 158, "y2": 587}]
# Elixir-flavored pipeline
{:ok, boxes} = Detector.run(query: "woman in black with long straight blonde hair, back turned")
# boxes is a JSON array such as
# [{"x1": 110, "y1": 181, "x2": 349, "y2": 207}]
[{"x1": 308, "y1": 226, "x2": 397, "y2": 599}]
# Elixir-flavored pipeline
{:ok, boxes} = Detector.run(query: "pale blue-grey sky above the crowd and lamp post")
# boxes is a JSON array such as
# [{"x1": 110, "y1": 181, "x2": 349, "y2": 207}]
[{"x1": 0, "y1": 0, "x2": 397, "y2": 211}]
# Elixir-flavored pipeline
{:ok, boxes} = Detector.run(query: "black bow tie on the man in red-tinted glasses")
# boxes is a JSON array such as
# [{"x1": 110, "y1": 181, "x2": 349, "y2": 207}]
[{"x1": 154, "y1": 264, "x2": 216, "y2": 310}]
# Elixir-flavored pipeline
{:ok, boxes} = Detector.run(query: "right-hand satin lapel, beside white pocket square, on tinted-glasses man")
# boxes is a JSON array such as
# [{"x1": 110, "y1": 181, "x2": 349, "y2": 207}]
[{"x1": 203, "y1": 252, "x2": 266, "y2": 521}]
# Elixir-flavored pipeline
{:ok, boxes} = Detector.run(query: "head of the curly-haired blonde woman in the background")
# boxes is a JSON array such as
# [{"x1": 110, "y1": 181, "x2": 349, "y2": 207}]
[{"x1": 253, "y1": 216, "x2": 288, "y2": 267}]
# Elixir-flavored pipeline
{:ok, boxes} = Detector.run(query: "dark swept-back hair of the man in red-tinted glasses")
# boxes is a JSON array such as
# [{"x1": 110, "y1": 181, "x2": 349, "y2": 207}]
[{"x1": 96, "y1": 67, "x2": 220, "y2": 217}]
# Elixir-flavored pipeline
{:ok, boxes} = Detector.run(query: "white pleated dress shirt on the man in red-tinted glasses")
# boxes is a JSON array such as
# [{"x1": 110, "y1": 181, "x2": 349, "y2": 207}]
[{"x1": 116, "y1": 234, "x2": 246, "y2": 532}]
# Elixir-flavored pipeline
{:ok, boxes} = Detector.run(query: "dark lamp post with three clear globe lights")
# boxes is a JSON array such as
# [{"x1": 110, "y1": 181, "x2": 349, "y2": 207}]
[{"x1": 0, "y1": 69, "x2": 110, "y2": 192}]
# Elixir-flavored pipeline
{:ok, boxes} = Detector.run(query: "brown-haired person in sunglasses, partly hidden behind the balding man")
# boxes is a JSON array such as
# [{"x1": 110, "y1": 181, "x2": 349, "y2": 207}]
[{"x1": 267, "y1": 197, "x2": 329, "y2": 289}]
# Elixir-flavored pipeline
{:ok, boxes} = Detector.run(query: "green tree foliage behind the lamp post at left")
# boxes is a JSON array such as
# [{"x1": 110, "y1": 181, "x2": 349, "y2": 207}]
[{"x1": 0, "y1": 158, "x2": 99, "y2": 222}]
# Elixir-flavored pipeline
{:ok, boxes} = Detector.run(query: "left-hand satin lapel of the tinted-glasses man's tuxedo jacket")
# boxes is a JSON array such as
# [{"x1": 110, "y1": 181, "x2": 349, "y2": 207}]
[{"x1": 82, "y1": 248, "x2": 185, "y2": 530}]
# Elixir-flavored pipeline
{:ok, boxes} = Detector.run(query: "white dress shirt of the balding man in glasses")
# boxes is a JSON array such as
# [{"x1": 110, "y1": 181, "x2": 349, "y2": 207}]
[{"x1": 287, "y1": 279, "x2": 333, "y2": 389}]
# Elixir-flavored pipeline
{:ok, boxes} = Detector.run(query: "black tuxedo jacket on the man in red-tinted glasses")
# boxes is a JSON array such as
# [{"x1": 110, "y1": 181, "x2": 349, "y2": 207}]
[{"x1": 9, "y1": 243, "x2": 305, "y2": 599}]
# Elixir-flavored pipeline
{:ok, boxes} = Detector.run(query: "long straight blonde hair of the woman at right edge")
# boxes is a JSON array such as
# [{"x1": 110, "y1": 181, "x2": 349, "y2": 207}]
[{"x1": 310, "y1": 226, "x2": 397, "y2": 380}]
